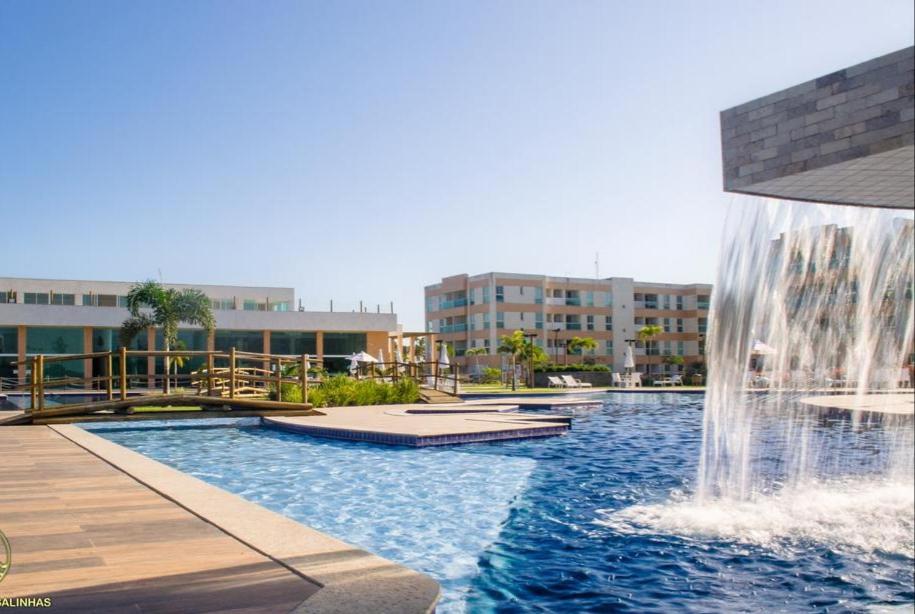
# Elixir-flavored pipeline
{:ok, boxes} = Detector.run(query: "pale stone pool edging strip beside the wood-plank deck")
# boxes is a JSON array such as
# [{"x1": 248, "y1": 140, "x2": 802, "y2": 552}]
[{"x1": 49, "y1": 425, "x2": 440, "y2": 614}]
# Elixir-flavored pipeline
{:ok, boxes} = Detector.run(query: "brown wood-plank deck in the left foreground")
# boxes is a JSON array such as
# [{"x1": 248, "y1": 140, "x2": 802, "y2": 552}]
[{"x1": 0, "y1": 426, "x2": 318, "y2": 612}]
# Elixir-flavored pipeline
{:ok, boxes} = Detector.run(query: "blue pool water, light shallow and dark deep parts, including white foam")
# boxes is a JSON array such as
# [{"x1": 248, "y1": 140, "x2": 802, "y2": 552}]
[{"x1": 85, "y1": 393, "x2": 915, "y2": 612}]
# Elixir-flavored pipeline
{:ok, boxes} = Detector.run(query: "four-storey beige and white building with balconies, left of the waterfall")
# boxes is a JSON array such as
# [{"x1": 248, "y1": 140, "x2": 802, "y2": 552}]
[{"x1": 425, "y1": 272, "x2": 712, "y2": 373}]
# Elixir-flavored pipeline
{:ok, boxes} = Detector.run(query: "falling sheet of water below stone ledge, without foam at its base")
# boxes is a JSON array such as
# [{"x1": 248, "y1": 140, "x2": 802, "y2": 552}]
[{"x1": 698, "y1": 199, "x2": 913, "y2": 500}]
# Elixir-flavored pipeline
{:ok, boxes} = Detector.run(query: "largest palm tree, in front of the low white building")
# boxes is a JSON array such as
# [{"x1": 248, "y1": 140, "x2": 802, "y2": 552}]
[{"x1": 118, "y1": 280, "x2": 216, "y2": 394}]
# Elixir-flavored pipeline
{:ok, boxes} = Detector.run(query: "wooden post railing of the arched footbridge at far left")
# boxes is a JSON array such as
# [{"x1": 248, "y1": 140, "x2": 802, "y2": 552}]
[{"x1": 6, "y1": 347, "x2": 321, "y2": 411}]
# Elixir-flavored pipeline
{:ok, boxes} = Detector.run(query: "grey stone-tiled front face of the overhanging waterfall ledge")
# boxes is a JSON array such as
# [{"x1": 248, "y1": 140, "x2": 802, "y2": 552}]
[{"x1": 721, "y1": 47, "x2": 915, "y2": 193}]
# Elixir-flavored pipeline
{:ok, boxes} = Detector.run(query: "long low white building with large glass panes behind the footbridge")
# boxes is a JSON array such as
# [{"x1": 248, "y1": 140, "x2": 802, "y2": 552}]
[{"x1": 0, "y1": 277, "x2": 398, "y2": 381}]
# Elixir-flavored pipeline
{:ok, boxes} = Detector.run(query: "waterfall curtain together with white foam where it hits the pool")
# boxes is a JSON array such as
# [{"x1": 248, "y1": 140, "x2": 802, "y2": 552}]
[{"x1": 607, "y1": 198, "x2": 915, "y2": 558}]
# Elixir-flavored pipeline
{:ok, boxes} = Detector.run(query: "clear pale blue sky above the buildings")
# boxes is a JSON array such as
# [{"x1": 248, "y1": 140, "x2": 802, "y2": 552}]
[{"x1": 0, "y1": 0, "x2": 913, "y2": 328}]
